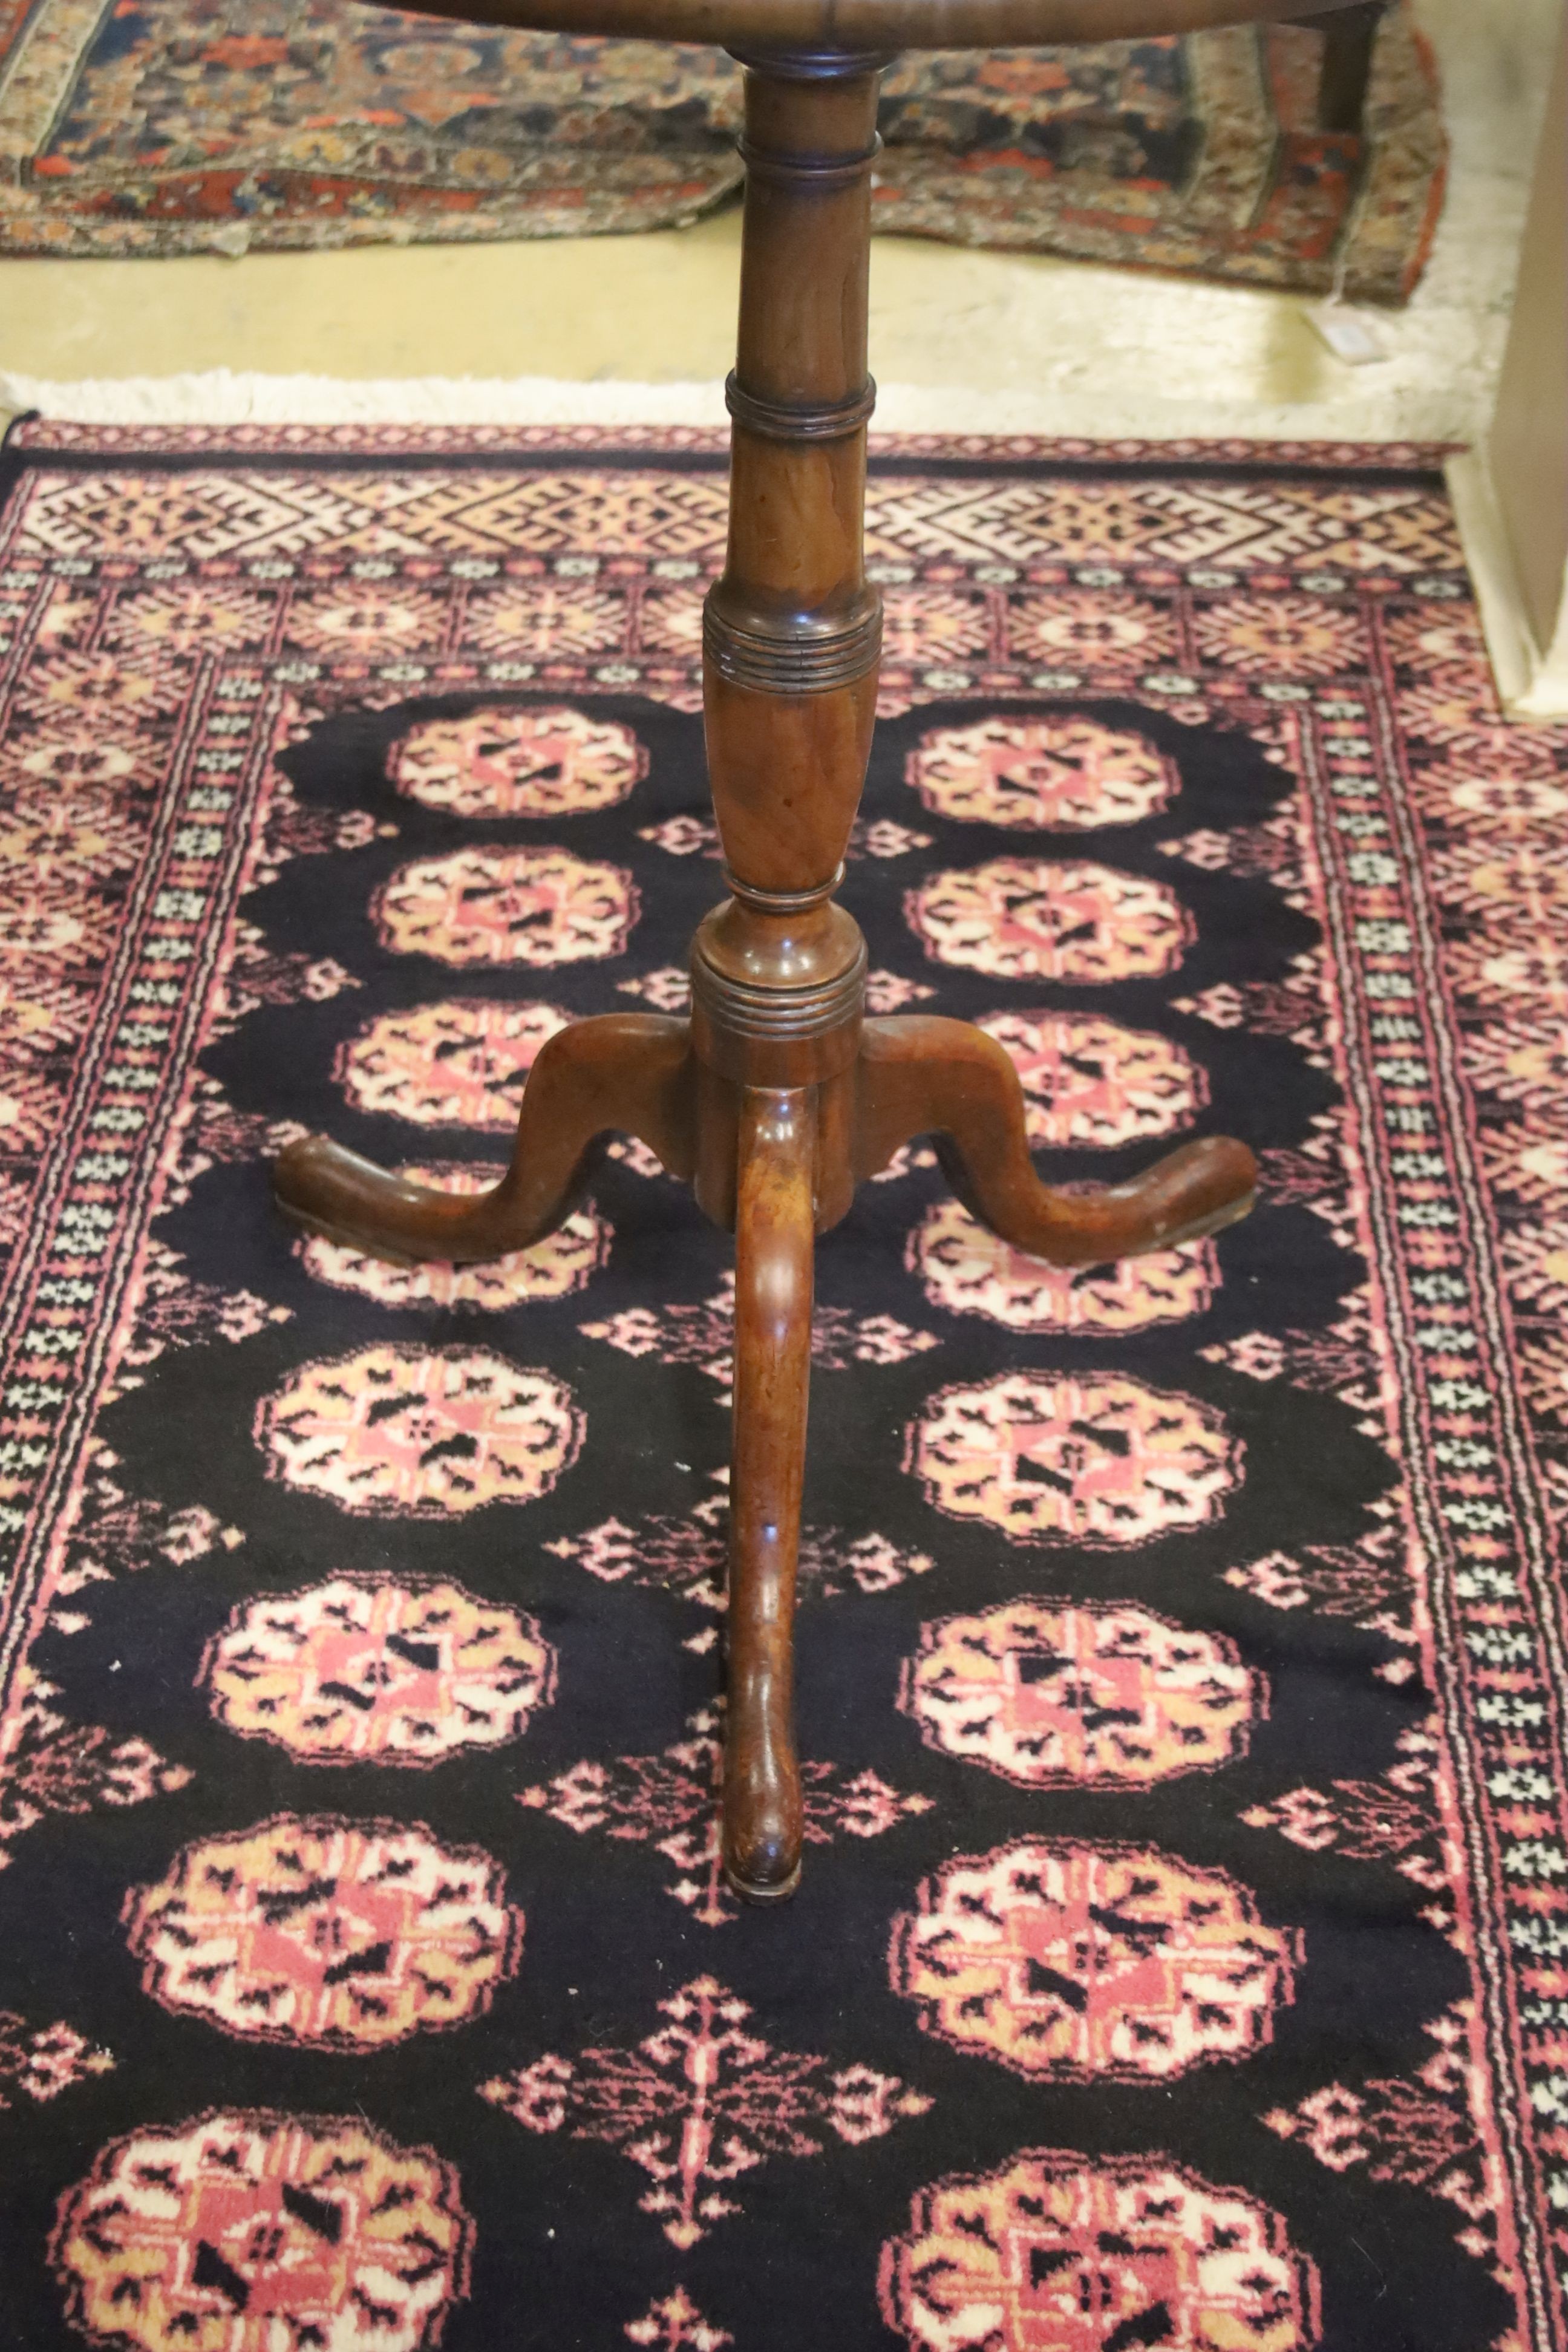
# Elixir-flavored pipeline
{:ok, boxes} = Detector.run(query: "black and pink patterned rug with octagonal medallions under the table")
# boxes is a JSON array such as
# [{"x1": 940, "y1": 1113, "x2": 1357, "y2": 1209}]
[{"x1": 0, "y1": 423, "x2": 1568, "y2": 2352}]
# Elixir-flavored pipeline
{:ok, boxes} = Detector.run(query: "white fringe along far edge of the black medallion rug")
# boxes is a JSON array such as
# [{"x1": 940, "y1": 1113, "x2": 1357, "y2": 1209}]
[{"x1": 0, "y1": 367, "x2": 1443, "y2": 442}]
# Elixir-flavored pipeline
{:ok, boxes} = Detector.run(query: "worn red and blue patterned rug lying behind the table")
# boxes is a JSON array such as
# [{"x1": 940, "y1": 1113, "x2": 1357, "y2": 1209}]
[{"x1": 0, "y1": 0, "x2": 1446, "y2": 301}]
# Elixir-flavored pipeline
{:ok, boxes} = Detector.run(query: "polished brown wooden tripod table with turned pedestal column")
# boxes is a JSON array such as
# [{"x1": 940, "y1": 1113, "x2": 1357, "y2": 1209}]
[{"x1": 275, "y1": 0, "x2": 1354, "y2": 1903}]
